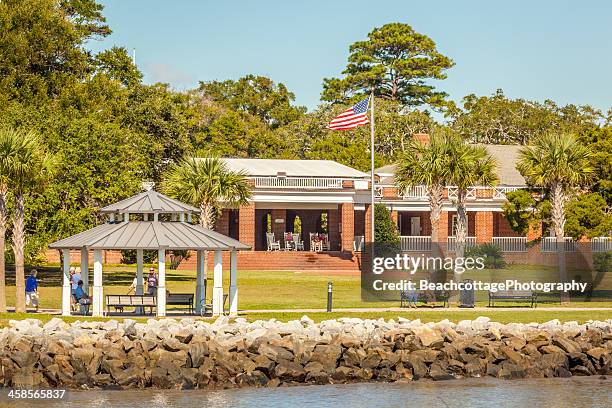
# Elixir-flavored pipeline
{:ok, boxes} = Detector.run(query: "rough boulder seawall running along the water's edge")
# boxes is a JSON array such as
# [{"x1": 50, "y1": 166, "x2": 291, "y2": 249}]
[{"x1": 0, "y1": 317, "x2": 612, "y2": 388}]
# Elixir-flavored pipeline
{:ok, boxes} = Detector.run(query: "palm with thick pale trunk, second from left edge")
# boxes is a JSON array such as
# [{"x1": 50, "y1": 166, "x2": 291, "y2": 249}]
[{"x1": 8, "y1": 130, "x2": 53, "y2": 313}]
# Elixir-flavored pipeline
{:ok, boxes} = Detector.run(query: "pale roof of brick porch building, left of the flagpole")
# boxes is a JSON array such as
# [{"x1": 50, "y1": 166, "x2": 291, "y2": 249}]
[{"x1": 213, "y1": 158, "x2": 368, "y2": 179}]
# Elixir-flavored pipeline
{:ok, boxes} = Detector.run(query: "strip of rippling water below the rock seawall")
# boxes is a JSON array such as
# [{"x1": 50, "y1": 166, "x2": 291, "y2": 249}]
[{"x1": 0, "y1": 377, "x2": 612, "y2": 408}]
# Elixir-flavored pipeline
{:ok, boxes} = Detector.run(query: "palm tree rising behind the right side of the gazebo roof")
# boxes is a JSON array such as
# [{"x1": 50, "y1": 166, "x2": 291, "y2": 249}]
[{"x1": 162, "y1": 158, "x2": 251, "y2": 284}]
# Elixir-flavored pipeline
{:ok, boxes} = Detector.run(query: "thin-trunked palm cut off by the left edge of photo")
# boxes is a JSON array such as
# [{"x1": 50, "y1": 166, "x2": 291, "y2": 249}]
[{"x1": 0, "y1": 128, "x2": 21, "y2": 313}]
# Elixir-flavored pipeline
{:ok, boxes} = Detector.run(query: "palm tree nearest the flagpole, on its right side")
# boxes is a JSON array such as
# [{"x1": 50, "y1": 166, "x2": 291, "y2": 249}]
[{"x1": 395, "y1": 133, "x2": 449, "y2": 255}]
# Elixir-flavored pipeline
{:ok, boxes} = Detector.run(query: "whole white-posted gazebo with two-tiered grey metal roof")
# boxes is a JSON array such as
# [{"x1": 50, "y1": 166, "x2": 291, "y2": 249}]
[{"x1": 49, "y1": 190, "x2": 250, "y2": 316}]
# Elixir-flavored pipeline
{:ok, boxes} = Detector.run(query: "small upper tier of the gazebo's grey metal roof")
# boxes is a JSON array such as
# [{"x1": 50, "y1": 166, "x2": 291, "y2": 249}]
[{"x1": 100, "y1": 190, "x2": 200, "y2": 214}]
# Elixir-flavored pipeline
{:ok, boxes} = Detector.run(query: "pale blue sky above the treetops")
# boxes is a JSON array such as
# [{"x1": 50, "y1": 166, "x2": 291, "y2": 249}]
[{"x1": 88, "y1": 0, "x2": 612, "y2": 111}]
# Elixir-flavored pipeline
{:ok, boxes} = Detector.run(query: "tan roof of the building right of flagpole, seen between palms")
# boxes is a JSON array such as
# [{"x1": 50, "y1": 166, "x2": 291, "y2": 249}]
[{"x1": 375, "y1": 144, "x2": 527, "y2": 187}]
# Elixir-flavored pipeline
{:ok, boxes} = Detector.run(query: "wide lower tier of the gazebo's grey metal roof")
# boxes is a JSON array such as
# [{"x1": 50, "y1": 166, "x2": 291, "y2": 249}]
[{"x1": 49, "y1": 221, "x2": 250, "y2": 250}]
